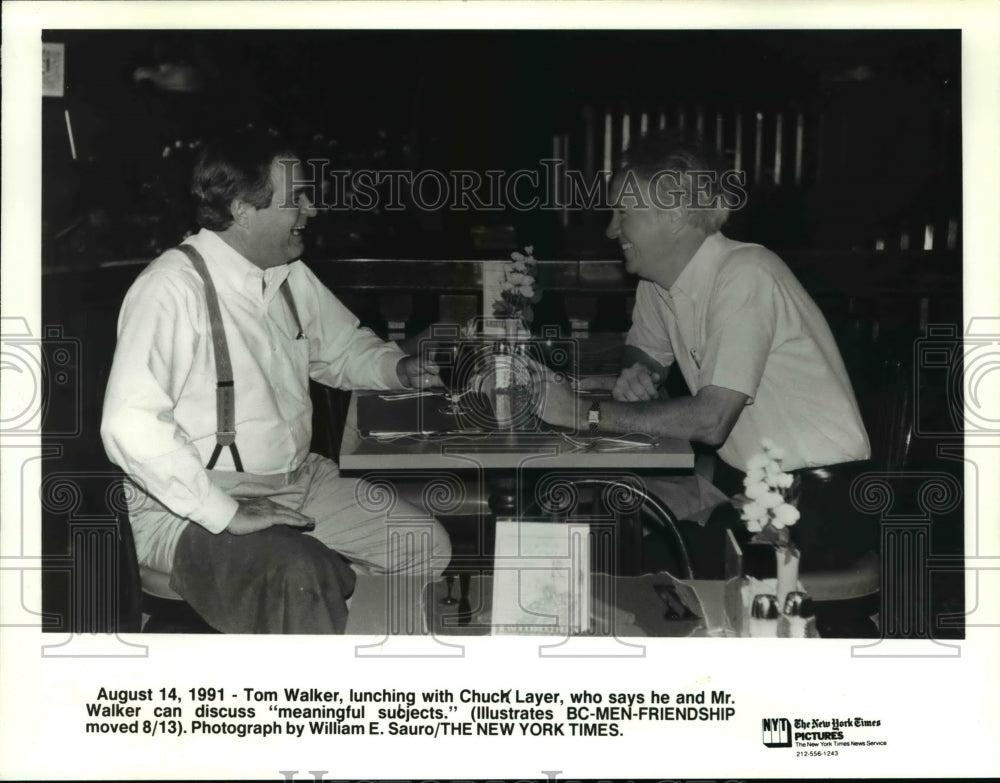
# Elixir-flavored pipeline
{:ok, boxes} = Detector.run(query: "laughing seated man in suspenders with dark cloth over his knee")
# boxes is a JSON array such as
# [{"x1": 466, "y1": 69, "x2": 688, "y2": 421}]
[{"x1": 101, "y1": 133, "x2": 451, "y2": 633}]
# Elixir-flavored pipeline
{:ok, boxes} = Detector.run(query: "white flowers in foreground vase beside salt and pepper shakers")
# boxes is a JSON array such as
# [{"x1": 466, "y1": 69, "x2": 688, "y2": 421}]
[{"x1": 733, "y1": 438, "x2": 799, "y2": 556}]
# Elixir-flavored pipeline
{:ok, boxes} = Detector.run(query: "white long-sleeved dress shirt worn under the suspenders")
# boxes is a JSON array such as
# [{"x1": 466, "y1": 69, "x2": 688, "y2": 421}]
[{"x1": 101, "y1": 229, "x2": 404, "y2": 562}]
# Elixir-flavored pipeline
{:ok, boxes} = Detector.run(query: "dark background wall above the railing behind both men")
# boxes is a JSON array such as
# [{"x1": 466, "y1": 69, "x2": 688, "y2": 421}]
[{"x1": 43, "y1": 30, "x2": 961, "y2": 266}]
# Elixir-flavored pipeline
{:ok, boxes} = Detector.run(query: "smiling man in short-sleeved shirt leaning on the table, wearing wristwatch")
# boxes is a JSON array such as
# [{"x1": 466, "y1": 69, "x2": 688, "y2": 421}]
[{"x1": 541, "y1": 132, "x2": 870, "y2": 572}]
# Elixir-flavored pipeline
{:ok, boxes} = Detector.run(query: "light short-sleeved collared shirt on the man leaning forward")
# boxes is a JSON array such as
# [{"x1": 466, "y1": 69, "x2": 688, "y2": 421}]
[{"x1": 628, "y1": 233, "x2": 870, "y2": 470}]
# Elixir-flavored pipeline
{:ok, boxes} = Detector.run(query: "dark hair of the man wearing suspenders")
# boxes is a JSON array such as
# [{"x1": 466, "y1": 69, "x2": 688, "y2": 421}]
[{"x1": 191, "y1": 128, "x2": 297, "y2": 231}]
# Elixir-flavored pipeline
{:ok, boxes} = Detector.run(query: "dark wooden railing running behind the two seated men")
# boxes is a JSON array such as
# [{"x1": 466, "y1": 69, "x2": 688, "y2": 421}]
[{"x1": 43, "y1": 250, "x2": 962, "y2": 340}]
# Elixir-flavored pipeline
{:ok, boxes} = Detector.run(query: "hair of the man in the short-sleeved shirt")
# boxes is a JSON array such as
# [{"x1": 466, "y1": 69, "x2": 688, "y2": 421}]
[{"x1": 621, "y1": 129, "x2": 729, "y2": 234}]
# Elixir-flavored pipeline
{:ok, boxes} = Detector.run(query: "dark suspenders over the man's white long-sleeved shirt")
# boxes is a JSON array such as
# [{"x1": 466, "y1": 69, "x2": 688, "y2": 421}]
[{"x1": 177, "y1": 245, "x2": 304, "y2": 473}]
